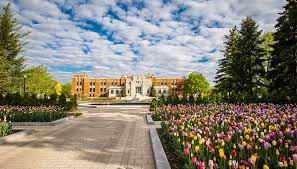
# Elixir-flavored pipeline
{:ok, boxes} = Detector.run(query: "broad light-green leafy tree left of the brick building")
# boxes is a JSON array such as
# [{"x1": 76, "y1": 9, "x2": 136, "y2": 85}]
[{"x1": 20, "y1": 66, "x2": 57, "y2": 95}]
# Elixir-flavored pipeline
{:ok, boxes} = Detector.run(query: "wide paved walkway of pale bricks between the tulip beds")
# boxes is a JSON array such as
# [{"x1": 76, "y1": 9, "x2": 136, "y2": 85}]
[{"x1": 0, "y1": 106, "x2": 155, "y2": 169}]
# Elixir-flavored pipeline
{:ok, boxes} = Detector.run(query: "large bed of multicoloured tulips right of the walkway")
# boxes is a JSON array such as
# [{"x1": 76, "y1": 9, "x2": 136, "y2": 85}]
[{"x1": 157, "y1": 104, "x2": 297, "y2": 169}]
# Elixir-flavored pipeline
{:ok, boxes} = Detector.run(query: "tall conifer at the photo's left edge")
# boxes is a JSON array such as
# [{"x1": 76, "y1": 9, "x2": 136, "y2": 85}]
[{"x1": 0, "y1": 3, "x2": 29, "y2": 91}]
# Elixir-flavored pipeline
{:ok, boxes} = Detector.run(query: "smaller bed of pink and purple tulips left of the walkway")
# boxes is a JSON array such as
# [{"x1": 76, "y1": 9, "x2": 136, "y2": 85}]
[{"x1": 0, "y1": 106, "x2": 67, "y2": 122}]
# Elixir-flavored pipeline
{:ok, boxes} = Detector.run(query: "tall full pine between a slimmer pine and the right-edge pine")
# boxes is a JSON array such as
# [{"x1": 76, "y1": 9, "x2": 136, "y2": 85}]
[{"x1": 231, "y1": 17, "x2": 265, "y2": 102}]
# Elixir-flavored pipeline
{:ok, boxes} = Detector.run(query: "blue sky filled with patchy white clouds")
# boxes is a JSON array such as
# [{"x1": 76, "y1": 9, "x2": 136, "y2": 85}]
[{"x1": 0, "y1": 0, "x2": 285, "y2": 82}]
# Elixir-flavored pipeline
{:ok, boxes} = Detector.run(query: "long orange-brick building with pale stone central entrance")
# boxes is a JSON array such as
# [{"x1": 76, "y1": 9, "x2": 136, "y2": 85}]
[{"x1": 71, "y1": 73, "x2": 185, "y2": 97}]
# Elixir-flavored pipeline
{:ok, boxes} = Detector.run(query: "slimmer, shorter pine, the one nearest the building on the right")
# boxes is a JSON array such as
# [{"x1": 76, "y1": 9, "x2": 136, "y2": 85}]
[{"x1": 215, "y1": 26, "x2": 238, "y2": 102}]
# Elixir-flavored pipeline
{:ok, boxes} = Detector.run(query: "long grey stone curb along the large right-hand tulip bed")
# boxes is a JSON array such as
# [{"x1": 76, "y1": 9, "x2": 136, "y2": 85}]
[{"x1": 149, "y1": 128, "x2": 171, "y2": 169}]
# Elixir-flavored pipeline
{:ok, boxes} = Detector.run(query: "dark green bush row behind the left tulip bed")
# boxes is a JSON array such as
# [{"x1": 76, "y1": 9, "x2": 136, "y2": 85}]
[{"x1": 0, "y1": 93, "x2": 77, "y2": 111}]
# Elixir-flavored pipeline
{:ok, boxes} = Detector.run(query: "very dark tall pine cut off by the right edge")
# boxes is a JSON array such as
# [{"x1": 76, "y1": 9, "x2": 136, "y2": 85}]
[{"x1": 269, "y1": 0, "x2": 297, "y2": 99}]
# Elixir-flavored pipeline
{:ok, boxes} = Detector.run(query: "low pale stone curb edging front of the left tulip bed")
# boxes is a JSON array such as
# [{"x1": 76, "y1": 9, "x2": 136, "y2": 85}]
[{"x1": 12, "y1": 116, "x2": 74, "y2": 126}]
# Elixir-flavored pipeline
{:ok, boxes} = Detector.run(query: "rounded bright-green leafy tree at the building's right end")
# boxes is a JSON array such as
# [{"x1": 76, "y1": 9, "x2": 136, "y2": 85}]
[{"x1": 184, "y1": 72, "x2": 210, "y2": 95}]
